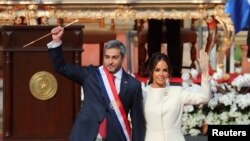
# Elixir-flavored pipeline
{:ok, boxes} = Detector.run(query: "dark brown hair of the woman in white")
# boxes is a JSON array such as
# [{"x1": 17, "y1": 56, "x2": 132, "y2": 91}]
[{"x1": 147, "y1": 52, "x2": 172, "y2": 84}]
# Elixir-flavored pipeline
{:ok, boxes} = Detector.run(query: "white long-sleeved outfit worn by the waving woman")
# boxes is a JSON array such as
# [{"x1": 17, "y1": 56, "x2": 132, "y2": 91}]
[{"x1": 143, "y1": 82, "x2": 210, "y2": 141}]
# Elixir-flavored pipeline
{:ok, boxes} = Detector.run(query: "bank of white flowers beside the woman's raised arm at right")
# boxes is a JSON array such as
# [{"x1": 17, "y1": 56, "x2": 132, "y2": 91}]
[{"x1": 182, "y1": 70, "x2": 250, "y2": 136}]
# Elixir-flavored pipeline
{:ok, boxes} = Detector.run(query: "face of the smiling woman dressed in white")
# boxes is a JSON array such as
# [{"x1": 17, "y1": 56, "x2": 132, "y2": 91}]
[{"x1": 152, "y1": 60, "x2": 169, "y2": 88}]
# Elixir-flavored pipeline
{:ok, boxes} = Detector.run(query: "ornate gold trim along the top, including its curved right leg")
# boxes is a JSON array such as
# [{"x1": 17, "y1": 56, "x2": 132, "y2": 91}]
[{"x1": 0, "y1": 0, "x2": 234, "y2": 72}]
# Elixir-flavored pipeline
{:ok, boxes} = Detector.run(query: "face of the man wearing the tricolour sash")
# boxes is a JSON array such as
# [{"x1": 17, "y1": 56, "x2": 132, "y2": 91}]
[{"x1": 103, "y1": 48, "x2": 123, "y2": 74}]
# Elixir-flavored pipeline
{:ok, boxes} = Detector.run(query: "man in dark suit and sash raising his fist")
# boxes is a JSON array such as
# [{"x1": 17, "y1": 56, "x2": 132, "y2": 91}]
[{"x1": 47, "y1": 26, "x2": 146, "y2": 141}]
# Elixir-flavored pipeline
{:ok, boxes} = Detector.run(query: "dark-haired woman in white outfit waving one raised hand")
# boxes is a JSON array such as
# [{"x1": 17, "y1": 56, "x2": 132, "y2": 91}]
[{"x1": 143, "y1": 49, "x2": 210, "y2": 141}]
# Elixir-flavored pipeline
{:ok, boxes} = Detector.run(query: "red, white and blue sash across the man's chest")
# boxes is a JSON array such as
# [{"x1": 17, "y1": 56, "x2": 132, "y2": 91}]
[{"x1": 97, "y1": 67, "x2": 131, "y2": 141}]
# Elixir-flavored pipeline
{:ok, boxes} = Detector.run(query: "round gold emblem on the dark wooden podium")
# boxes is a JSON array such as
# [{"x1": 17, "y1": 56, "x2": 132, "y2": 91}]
[{"x1": 29, "y1": 71, "x2": 57, "y2": 100}]
